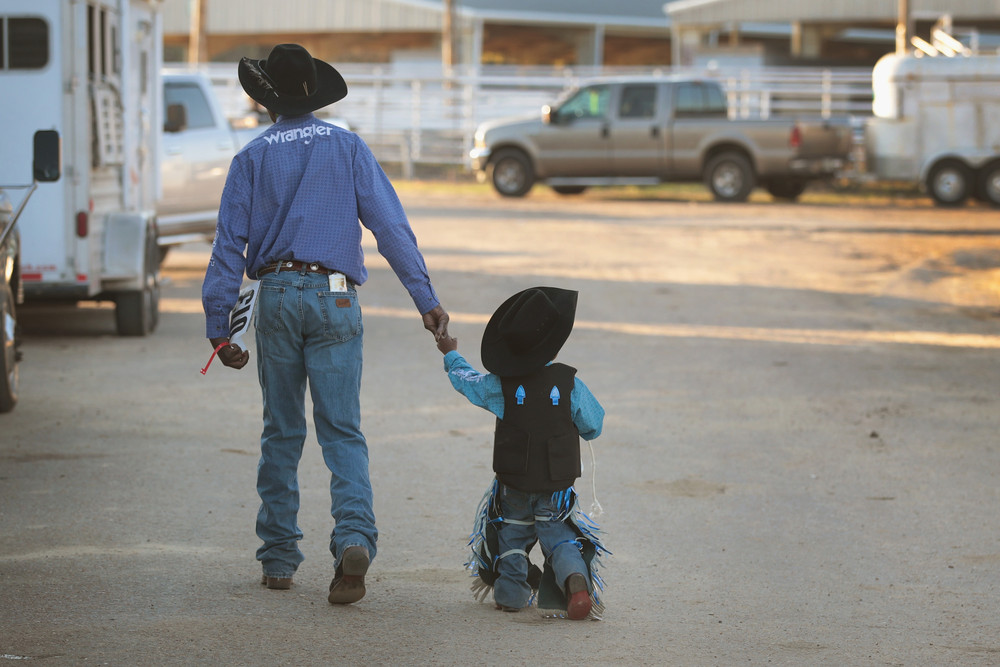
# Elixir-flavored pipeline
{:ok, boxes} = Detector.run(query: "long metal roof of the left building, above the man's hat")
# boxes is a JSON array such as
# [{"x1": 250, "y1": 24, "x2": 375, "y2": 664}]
[{"x1": 162, "y1": 0, "x2": 677, "y2": 34}]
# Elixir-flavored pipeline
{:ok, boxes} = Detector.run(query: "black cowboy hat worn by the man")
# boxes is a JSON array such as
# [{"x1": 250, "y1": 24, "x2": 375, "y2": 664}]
[{"x1": 239, "y1": 44, "x2": 347, "y2": 116}]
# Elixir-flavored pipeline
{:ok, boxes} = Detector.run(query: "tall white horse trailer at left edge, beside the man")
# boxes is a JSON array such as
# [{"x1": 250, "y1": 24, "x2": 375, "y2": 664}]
[{"x1": 0, "y1": 0, "x2": 162, "y2": 335}]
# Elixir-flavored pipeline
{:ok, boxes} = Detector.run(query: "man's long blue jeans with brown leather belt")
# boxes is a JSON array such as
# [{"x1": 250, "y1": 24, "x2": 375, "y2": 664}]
[{"x1": 255, "y1": 271, "x2": 378, "y2": 577}]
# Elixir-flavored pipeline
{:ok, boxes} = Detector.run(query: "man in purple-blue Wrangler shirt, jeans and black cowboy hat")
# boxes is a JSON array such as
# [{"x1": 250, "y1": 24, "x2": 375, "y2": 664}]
[{"x1": 202, "y1": 44, "x2": 448, "y2": 604}]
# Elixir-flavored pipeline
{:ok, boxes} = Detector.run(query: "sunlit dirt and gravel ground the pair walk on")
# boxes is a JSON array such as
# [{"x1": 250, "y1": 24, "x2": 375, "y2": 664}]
[{"x1": 0, "y1": 184, "x2": 1000, "y2": 666}]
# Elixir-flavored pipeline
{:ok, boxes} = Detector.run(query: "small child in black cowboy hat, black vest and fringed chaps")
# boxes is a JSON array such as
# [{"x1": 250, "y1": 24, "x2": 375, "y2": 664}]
[{"x1": 437, "y1": 287, "x2": 607, "y2": 620}]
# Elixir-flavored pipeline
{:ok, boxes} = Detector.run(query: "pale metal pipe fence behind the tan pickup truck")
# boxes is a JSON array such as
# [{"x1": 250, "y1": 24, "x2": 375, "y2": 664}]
[{"x1": 182, "y1": 63, "x2": 872, "y2": 176}]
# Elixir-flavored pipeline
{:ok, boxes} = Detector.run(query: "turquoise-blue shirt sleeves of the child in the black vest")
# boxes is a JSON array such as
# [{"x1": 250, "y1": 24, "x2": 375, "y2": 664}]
[{"x1": 444, "y1": 350, "x2": 604, "y2": 440}]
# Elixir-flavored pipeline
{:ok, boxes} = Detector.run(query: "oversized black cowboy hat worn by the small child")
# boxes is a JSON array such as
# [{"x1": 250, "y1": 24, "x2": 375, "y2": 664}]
[{"x1": 480, "y1": 287, "x2": 579, "y2": 376}]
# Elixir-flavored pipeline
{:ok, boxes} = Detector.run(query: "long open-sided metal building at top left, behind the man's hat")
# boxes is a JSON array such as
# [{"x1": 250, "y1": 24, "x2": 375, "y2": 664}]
[{"x1": 164, "y1": 0, "x2": 670, "y2": 65}]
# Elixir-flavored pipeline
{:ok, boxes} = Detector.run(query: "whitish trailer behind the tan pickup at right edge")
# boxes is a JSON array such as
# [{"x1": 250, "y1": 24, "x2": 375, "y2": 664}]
[{"x1": 865, "y1": 54, "x2": 1000, "y2": 206}]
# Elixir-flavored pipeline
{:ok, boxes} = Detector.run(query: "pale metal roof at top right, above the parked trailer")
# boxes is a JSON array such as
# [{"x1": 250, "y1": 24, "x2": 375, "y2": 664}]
[{"x1": 666, "y1": 0, "x2": 1000, "y2": 24}]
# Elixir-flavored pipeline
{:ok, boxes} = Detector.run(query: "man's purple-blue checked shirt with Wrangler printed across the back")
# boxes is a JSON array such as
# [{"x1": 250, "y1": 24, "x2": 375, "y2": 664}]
[{"x1": 202, "y1": 114, "x2": 439, "y2": 338}]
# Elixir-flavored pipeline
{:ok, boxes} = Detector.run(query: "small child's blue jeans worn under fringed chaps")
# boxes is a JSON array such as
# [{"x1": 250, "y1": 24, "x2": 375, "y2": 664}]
[{"x1": 493, "y1": 484, "x2": 590, "y2": 609}]
